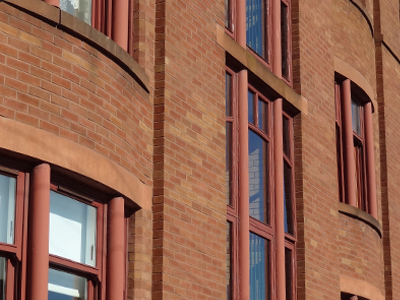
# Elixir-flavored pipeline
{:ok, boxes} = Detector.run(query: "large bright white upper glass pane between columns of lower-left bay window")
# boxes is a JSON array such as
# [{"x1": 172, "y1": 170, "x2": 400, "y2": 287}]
[{"x1": 49, "y1": 191, "x2": 96, "y2": 266}]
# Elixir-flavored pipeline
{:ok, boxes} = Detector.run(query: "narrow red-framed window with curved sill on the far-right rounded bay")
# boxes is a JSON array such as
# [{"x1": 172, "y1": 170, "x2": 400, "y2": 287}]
[{"x1": 335, "y1": 79, "x2": 377, "y2": 218}]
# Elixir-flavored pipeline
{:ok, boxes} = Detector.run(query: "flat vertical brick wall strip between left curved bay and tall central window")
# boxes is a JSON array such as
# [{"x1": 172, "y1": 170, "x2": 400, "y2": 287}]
[{"x1": 153, "y1": 0, "x2": 226, "y2": 299}]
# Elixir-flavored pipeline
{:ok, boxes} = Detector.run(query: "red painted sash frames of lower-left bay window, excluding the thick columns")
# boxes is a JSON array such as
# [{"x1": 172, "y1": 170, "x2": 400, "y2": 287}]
[{"x1": 0, "y1": 165, "x2": 129, "y2": 300}]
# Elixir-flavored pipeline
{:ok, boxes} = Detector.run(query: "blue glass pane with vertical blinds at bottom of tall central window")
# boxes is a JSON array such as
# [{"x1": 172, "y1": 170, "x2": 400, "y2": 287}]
[{"x1": 250, "y1": 232, "x2": 270, "y2": 300}]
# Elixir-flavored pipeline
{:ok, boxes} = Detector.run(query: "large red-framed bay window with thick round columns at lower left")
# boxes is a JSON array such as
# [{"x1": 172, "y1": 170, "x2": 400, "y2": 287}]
[{"x1": 0, "y1": 164, "x2": 127, "y2": 300}]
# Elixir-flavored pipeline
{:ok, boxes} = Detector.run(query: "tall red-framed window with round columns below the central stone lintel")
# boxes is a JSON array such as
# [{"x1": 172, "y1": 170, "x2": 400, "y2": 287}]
[{"x1": 226, "y1": 69, "x2": 296, "y2": 300}]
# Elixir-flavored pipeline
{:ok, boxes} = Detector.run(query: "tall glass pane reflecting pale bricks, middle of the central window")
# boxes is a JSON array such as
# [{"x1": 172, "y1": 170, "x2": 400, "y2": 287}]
[{"x1": 249, "y1": 130, "x2": 269, "y2": 223}]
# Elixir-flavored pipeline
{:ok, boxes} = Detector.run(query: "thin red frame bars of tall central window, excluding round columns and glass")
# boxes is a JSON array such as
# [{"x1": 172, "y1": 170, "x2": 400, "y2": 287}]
[{"x1": 226, "y1": 67, "x2": 297, "y2": 300}]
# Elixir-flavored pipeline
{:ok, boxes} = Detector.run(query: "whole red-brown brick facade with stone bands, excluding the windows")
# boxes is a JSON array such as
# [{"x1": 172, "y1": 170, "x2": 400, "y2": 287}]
[{"x1": 0, "y1": 0, "x2": 400, "y2": 300}]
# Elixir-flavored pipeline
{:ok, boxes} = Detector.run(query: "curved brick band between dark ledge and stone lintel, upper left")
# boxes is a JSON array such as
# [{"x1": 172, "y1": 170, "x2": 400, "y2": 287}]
[{"x1": 0, "y1": 3, "x2": 152, "y2": 185}]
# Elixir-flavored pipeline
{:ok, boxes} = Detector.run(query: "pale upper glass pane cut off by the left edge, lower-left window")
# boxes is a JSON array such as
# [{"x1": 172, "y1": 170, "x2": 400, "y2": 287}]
[{"x1": 0, "y1": 174, "x2": 17, "y2": 244}]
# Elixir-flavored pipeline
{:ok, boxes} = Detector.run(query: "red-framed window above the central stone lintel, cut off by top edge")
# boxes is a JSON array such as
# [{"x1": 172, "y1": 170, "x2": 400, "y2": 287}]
[{"x1": 225, "y1": 0, "x2": 292, "y2": 85}]
